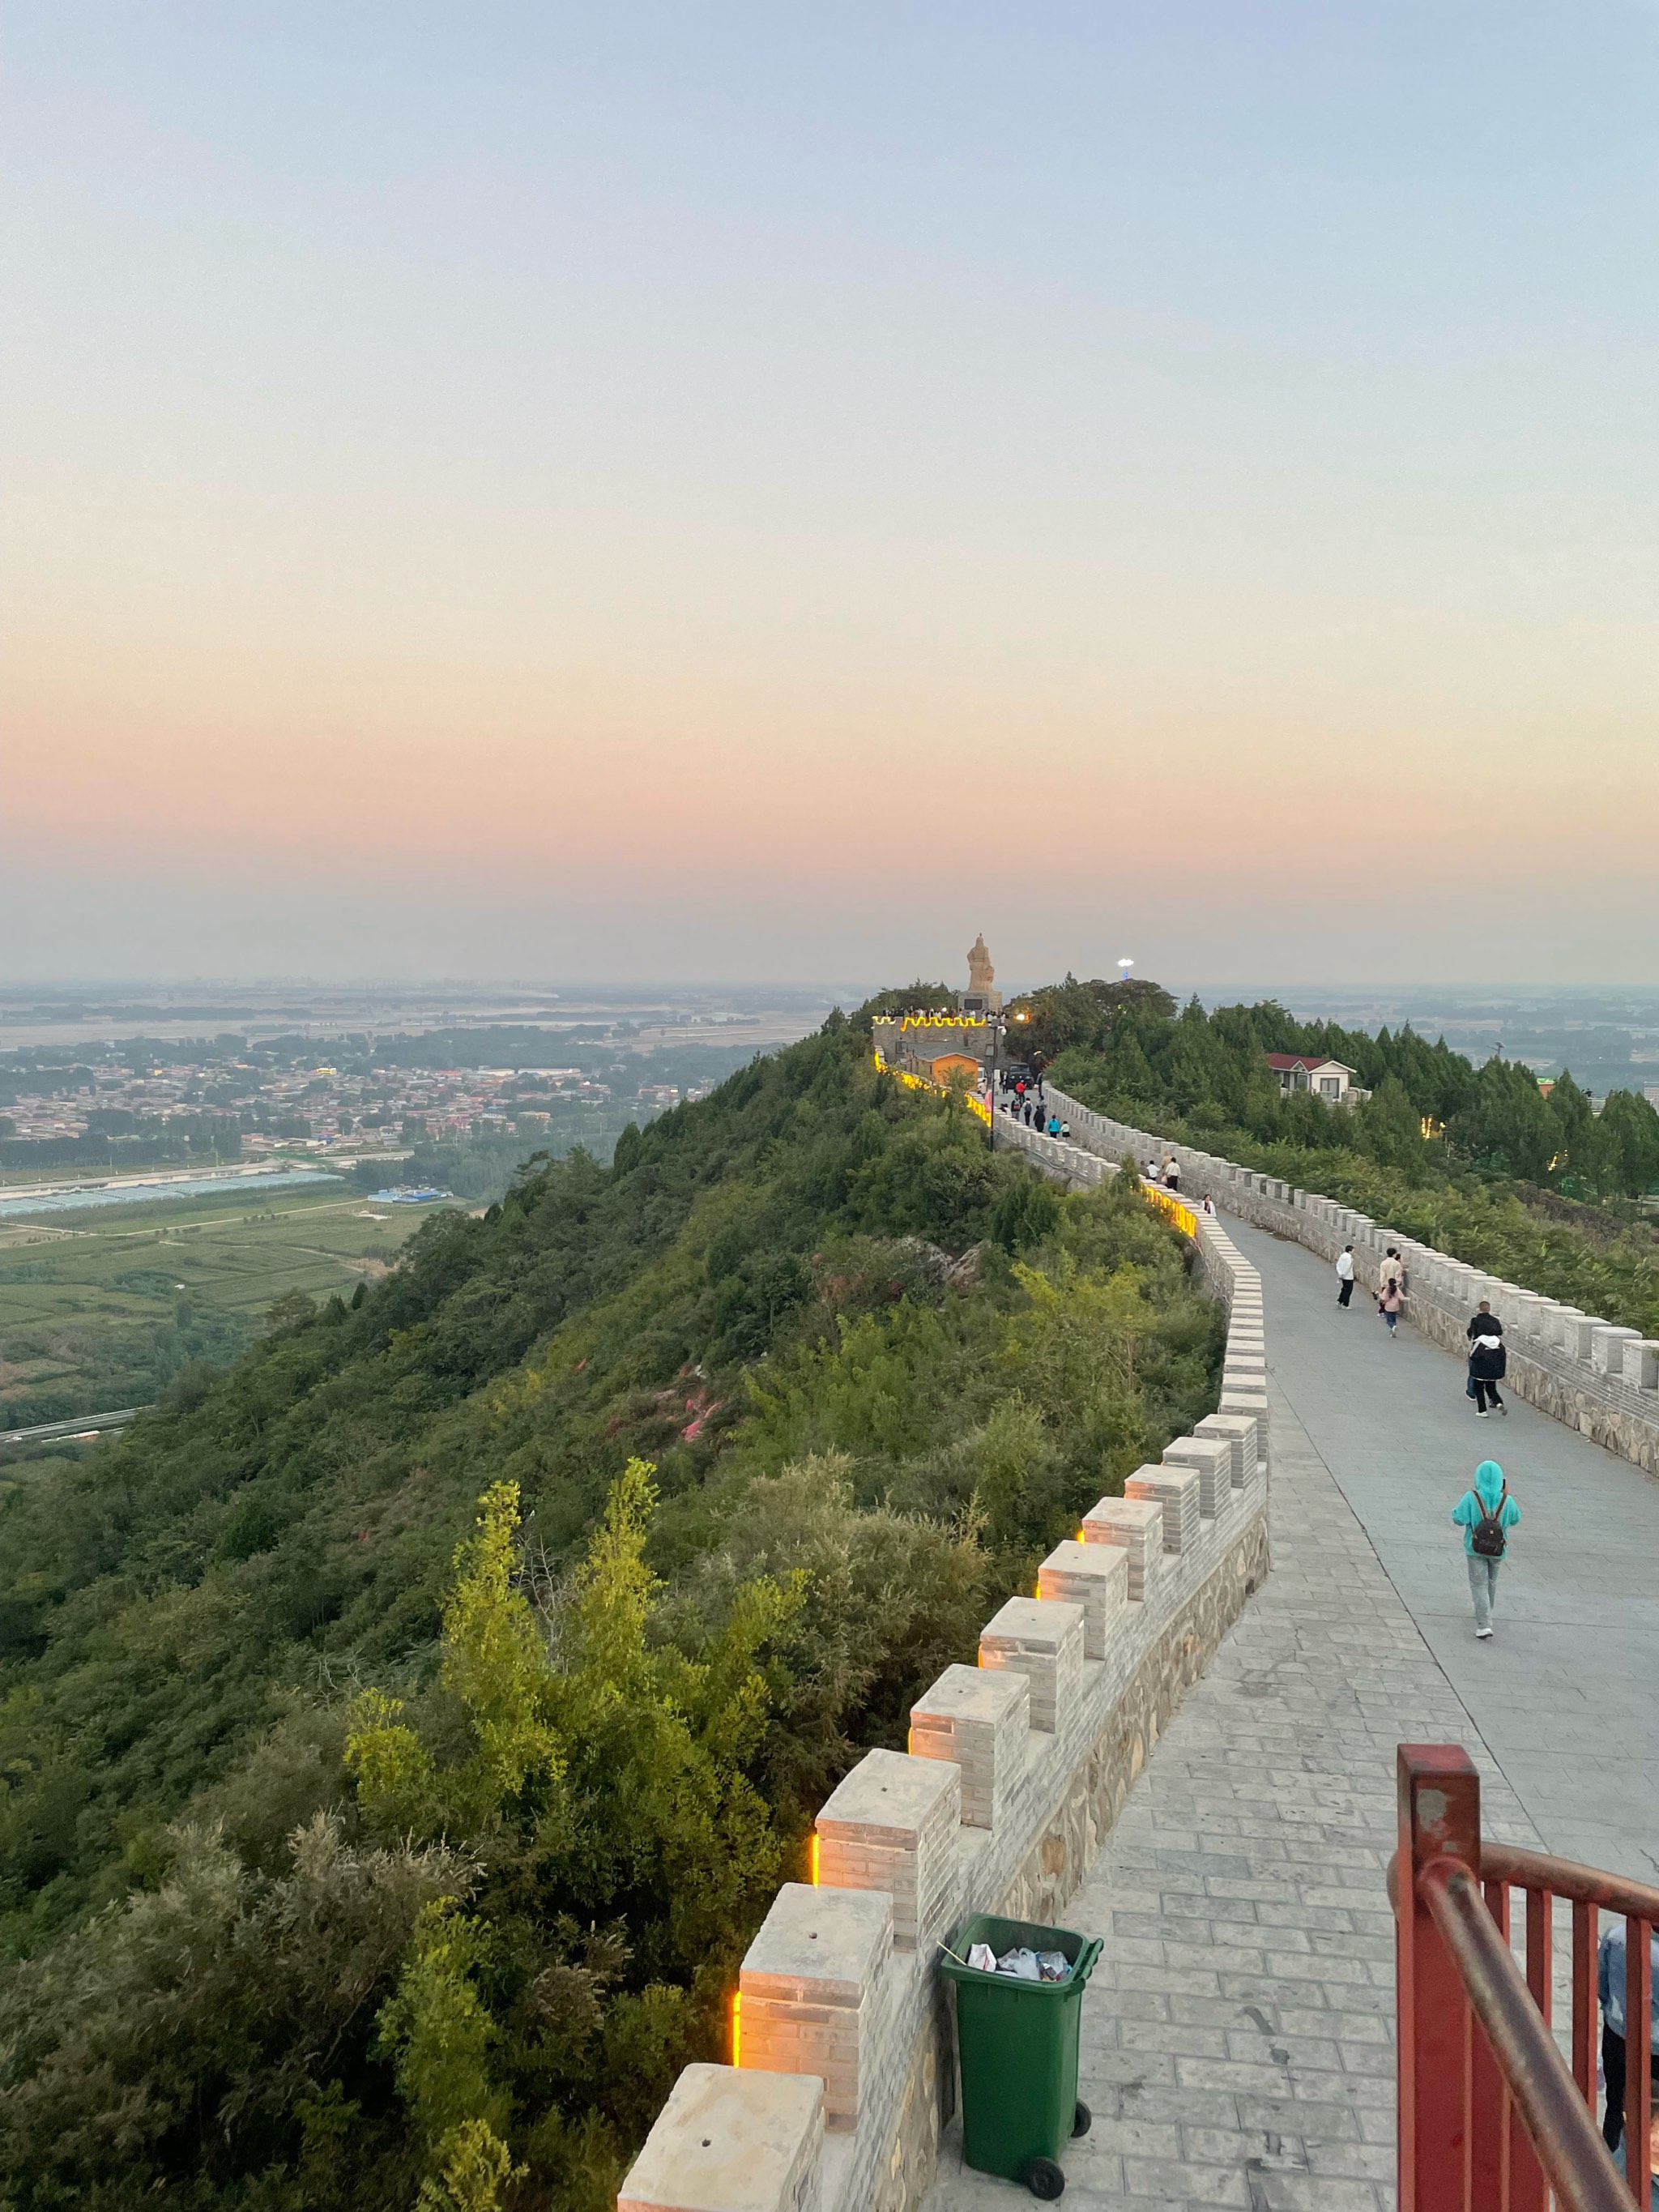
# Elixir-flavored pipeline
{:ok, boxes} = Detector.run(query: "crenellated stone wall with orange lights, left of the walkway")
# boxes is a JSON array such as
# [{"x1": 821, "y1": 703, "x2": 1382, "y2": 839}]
[{"x1": 617, "y1": 1212, "x2": 1268, "y2": 2212}]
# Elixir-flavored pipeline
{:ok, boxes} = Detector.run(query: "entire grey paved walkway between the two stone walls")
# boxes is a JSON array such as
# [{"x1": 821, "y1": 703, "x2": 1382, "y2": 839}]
[{"x1": 929, "y1": 1221, "x2": 1659, "y2": 2212}]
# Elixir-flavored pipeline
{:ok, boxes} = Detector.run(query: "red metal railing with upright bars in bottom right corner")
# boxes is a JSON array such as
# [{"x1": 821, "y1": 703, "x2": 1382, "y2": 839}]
[{"x1": 1389, "y1": 1743, "x2": 1659, "y2": 2212}]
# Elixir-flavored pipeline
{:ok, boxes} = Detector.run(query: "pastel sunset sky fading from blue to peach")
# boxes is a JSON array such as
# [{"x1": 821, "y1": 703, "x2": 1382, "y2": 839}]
[{"x1": 0, "y1": 0, "x2": 1659, "y2": 984}]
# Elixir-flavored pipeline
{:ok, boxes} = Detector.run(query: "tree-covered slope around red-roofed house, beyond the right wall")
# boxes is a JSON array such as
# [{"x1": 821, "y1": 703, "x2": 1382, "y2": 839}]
[{"x1": 1013, "y1": 978, "x2": 1659, "y2": 1336}]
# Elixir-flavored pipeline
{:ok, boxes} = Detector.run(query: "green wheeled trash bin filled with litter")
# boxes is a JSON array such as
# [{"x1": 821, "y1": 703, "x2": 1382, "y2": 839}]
[{"x1": 940, "y1": 1913, "x2": 1102, "y2": 2197}]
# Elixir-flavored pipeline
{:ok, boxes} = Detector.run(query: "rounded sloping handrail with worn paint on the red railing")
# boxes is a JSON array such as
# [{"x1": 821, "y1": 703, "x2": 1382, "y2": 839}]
[{"x1": 1418, "y1": 1845, "x2": 1646, "y2": 2212}]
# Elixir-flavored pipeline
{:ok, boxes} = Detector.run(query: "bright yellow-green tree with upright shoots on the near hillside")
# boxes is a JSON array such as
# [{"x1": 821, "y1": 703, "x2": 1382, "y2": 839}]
[{"x1": 348, "y1": 1460, "x2": 803, "y2": 2208}]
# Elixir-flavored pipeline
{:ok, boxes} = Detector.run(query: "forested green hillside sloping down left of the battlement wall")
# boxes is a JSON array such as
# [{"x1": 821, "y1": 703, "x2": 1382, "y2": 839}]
[{"x1": 0, "y1": 1018, "x2": 1221, "y2": 2212}]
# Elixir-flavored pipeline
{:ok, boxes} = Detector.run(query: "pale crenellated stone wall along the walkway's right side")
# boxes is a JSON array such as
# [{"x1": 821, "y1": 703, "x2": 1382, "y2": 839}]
[{"x1": 1039, "y1": 1084, "x2": 1659, "y2": 1473}]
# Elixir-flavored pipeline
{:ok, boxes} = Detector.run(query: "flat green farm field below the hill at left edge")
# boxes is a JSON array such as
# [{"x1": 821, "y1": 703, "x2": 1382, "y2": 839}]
[{"x1": 0, "y1": 1179, "x2": 458, "y2": 1429}]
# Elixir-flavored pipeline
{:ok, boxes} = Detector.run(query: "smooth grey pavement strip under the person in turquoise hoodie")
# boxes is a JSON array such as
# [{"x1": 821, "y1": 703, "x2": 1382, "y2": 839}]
[{"x1": 1228, "y1": 1221, "x2": 1659, "y2": 1882}]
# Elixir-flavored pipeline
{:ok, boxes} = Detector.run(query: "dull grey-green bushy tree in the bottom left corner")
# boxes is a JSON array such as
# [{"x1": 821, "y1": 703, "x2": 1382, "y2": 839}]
[{"x1": 0, "y1": 1814, "x2": 464, "y2": 2212}]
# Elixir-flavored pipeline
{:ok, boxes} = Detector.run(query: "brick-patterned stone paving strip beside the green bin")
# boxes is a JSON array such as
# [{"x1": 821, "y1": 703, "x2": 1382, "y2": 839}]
[{"x1": 929, "y1": 1389, "x2": 1540, "y2": 2212}]
